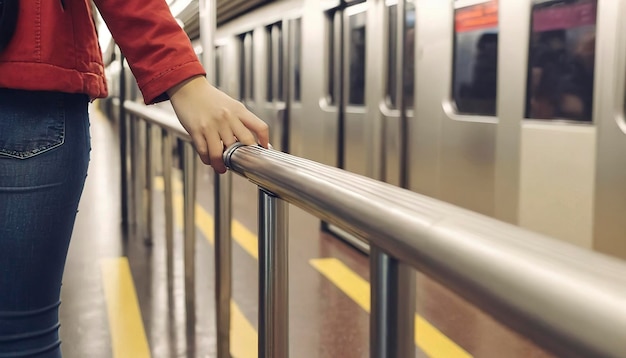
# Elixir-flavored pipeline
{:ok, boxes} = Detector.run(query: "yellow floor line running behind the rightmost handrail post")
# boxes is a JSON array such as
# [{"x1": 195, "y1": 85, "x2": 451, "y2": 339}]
[{"x1": 310, "y1": 258, "x2": 472, "y2": 358}]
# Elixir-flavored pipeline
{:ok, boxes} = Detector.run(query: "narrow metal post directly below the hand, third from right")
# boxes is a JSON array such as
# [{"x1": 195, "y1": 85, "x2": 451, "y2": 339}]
[{"x1": 213, "y1": 172, "x2": 232, "y2": 358}]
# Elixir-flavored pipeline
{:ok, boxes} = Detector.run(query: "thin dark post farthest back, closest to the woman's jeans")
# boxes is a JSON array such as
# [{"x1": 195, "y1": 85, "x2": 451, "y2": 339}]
[{"x1": 119, "y1": 52, "x2": 129, "y2": 234}]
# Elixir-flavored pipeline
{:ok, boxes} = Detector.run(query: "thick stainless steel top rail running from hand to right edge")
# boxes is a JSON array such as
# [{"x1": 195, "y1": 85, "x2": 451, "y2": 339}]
[{"x1": 224, "y1": 147, "x2": 626, "y2": 357}]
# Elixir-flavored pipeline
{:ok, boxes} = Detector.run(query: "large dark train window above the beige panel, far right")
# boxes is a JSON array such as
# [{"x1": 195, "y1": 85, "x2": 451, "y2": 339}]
[{"x1": 526, "y1": 0, "x2": 597, "y2": 122}]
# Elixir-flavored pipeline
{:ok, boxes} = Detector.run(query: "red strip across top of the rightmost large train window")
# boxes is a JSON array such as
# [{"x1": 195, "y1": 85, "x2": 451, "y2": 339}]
[{"x1": 533, "y1": 1, "x2": 597, "y2": 32}]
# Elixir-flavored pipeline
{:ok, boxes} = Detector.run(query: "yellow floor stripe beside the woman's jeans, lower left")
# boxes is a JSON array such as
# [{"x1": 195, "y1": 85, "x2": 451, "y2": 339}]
[{"x1": 100, "y1": 257, "x2": 150, "y2": 358}]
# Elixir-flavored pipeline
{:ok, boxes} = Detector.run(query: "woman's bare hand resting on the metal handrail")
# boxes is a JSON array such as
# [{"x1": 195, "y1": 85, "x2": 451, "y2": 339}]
[{"x1": 167, "y1": 76, "x2": 269, "y2": 173}]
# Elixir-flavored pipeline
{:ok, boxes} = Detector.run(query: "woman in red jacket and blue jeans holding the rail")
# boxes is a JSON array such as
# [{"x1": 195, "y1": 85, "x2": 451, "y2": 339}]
[{"x1": 0, "y1": 0, "x2": 268, "y2": 358}]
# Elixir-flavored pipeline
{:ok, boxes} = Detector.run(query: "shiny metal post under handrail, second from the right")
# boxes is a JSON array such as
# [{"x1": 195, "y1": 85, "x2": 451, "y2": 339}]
[{"x1": 259, "y1": 189, "x2": 289, "y2": 358}]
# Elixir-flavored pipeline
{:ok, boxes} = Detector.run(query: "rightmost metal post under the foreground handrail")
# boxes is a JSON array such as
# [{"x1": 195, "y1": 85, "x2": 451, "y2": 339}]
[{"x1": 370, "y1": 246, "x2": 416, "y2": 358}]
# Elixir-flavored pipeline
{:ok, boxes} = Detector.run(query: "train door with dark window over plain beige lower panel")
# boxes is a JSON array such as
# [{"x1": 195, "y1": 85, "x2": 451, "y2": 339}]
[{"x1": 519, "y1": 0, "x2": 596, "y2": 248}]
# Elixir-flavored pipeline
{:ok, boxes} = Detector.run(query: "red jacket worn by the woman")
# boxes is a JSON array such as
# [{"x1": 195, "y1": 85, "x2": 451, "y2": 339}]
[{"x1": 0, "y1": 0, "x2": 205, "y2": 104}]
